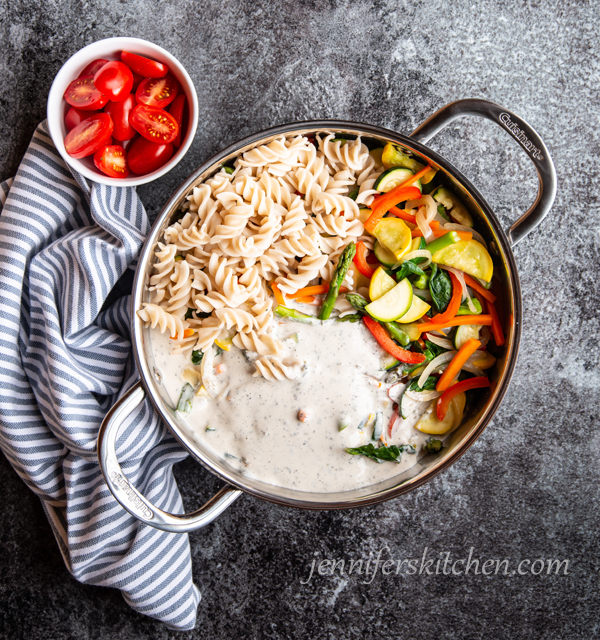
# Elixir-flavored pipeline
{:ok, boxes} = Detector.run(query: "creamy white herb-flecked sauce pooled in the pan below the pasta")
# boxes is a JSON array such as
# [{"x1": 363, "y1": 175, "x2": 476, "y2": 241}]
[{"x1": 150, "y1": 321, "x2": 429, "y2": 492}]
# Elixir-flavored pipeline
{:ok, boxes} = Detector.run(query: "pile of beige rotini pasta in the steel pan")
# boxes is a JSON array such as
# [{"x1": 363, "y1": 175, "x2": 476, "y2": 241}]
[{"x1": 138, "y1": 133, "x2": 383, "y2": 380}]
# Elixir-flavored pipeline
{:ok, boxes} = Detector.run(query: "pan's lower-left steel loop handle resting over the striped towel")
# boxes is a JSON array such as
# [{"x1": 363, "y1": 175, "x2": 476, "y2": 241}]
[{"x1": 97, "y1": 382, "x2": 242, "y2": 533}]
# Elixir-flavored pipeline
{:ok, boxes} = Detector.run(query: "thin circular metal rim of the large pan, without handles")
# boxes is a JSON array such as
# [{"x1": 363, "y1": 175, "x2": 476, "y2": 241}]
[{"x1": 130, "y1": 120, "x2": 522, "y2": 510}]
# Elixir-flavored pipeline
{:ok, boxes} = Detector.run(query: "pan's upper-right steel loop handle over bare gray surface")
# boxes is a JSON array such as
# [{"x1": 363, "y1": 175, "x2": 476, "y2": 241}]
[{"x1": 410, "y1": 99, "x2": 556, "y2": 247}]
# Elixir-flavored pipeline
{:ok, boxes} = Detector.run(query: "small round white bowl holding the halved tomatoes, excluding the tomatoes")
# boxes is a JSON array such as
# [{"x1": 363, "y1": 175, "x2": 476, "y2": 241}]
[{"x1": 47, "y1": 38, "x2": 198, "y2": 187}]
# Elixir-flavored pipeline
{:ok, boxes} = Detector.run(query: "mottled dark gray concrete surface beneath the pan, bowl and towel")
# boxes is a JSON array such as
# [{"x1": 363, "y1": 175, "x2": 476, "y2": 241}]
[{"x1": 0, "y1": 0, "x2": 600, "y2": 640}]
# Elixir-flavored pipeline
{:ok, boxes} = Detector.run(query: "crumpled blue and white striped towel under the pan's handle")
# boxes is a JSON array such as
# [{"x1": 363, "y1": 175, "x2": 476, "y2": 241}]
[{"x1": 0, "y1": 122, "x2": 200, "y2": 629}]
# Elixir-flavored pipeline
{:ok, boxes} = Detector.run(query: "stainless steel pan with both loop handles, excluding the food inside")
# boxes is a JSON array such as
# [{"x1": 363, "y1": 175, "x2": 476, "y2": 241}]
[{"x1": 98, "y1": 100, "x2": 556, "y2": 532}]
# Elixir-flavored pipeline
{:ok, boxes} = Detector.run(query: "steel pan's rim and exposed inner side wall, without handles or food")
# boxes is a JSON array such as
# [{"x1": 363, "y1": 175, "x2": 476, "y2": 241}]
[{"x1": 132, "y1": 121, "x2": 521, "y2": 509}]
